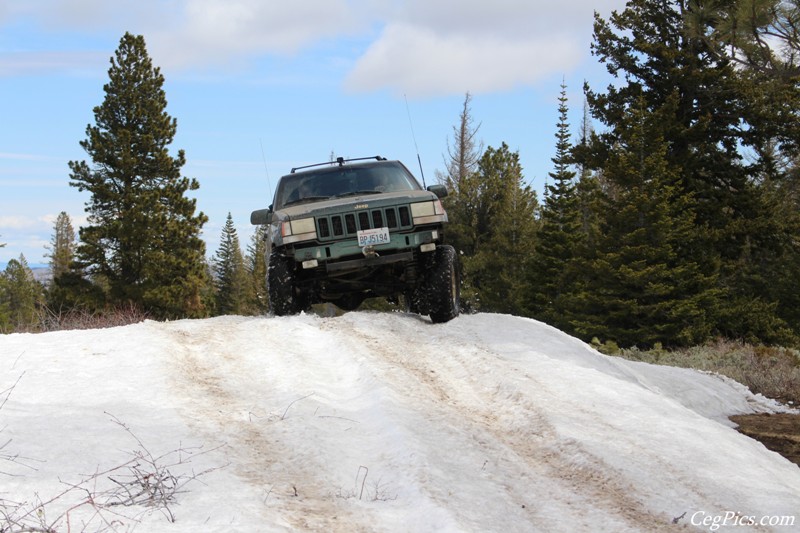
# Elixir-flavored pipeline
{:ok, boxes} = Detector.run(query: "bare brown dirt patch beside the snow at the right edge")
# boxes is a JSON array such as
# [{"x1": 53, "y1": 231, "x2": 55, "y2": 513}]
[{"x1": 730, "y1": 413, "x2": 800, "y2": 466}]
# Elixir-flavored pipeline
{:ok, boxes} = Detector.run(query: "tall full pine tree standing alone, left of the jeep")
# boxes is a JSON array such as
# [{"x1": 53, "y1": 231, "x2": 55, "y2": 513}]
[{"x1": 69, "y1": 33, "x2": 207, "y2": 317}]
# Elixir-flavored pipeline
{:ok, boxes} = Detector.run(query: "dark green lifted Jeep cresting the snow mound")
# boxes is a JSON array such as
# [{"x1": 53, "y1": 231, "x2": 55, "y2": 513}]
[{"x1": 250, "y1": 156, "x2": 460, "y2": 322}]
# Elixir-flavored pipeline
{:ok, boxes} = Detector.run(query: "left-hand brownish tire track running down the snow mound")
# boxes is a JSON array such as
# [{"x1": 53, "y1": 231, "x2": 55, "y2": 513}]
[{"x1": 170, "y1": 320, "x2": 369, "y2": 532}]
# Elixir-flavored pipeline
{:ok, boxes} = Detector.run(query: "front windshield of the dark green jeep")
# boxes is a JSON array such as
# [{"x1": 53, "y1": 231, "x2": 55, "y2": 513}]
[{"x1": 274, "y1": 161, "x2": 421, "y2": 210}]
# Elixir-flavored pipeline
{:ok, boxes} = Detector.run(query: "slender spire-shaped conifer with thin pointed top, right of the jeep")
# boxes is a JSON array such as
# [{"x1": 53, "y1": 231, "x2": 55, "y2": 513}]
[{"x1": 528, "y1": 83, "x2": 584, "y2": 329}]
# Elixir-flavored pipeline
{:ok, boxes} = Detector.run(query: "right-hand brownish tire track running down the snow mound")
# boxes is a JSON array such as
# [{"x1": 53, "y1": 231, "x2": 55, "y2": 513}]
[{"x1": 325, "y1": 315, "x2": 672, "y2": 531}]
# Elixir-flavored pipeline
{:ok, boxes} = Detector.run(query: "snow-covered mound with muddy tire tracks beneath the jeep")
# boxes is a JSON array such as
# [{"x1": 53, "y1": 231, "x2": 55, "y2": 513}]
[{"x1": 0, "y1": 313, "x2": 800, "y2": 532}]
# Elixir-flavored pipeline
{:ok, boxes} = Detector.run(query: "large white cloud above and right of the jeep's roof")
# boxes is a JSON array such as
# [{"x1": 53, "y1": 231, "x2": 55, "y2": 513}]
[{"x1": 346, "y1": 0, "x2": 624, "y2": 96}]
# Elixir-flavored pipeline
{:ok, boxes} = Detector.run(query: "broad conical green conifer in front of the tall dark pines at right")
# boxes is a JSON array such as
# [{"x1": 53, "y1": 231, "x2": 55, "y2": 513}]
[{"x1": 571, "y1": 99, "x2": 719, "y2": 347}]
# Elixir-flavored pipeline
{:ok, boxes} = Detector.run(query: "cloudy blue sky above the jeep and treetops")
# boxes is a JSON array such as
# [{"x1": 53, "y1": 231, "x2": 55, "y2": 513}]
[{"x1": 0, "y1": 0, "x2": 624, "y2": 265}]
